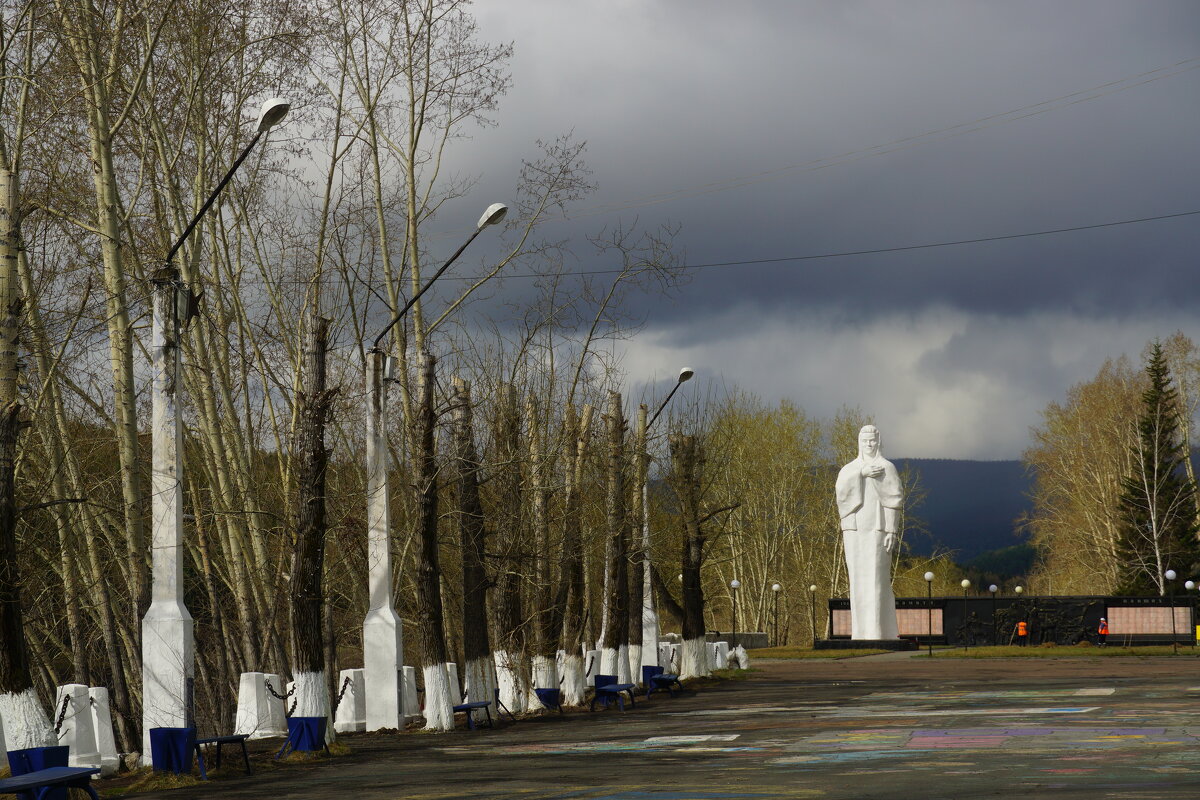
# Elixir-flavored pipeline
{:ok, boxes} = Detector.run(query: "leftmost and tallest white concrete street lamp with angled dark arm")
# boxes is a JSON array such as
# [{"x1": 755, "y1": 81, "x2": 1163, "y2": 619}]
[{"x1": 142, "y1": 97, "x2": 292, "y2": 764}]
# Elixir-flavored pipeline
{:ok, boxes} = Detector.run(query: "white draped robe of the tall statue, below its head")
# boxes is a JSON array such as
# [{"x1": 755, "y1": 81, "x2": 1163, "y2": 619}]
[{"x1": 838, "y1": 456, "x2": 902, "y2": 639}]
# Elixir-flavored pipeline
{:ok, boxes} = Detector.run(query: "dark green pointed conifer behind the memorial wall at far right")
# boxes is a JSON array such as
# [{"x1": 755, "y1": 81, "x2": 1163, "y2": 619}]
[{"x1": 1117, "y1": 341, "x2": 1200, "y2": 596}]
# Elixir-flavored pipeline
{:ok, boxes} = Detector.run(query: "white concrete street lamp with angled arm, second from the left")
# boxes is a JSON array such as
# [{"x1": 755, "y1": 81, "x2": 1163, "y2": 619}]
[{"x1": 362, "y1": 203, "x2": 509, "y2": 730}]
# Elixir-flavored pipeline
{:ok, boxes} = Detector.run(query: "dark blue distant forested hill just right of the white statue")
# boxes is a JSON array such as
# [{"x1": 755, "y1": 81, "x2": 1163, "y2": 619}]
[{"x1": 893, "y1": 458, "x2": 1031, "y2": 564}]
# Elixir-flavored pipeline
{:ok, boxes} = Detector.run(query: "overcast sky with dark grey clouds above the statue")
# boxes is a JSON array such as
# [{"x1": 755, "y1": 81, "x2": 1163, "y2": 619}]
[{"x1": 443, "y1": 0, "x2": 1200, "y2": 458}]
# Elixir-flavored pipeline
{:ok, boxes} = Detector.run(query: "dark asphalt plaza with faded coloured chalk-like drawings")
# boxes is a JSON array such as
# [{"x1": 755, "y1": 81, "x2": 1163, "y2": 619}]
[{"x1": 127, "y1": 654, "x2": 1200, "y2": 800}]
